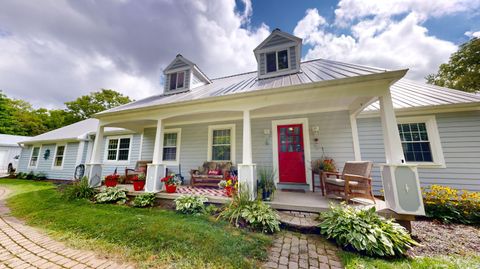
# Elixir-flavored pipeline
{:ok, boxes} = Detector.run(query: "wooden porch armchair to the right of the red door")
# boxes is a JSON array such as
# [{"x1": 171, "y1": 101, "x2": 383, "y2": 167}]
[{"x1": 323, "y1": 161, "x2": 375, "y2": 203}]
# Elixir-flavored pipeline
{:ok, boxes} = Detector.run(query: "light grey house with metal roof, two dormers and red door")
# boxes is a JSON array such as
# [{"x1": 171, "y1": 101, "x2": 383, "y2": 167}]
[{"x1": 20, "y1": 29, "x2": 480, "y2": 210}]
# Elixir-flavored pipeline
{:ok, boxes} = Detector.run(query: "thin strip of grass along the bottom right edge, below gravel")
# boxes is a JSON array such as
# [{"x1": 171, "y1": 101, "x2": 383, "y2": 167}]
[{"x1": 339, "y1": 252, "x2": 480, "y2": 269}]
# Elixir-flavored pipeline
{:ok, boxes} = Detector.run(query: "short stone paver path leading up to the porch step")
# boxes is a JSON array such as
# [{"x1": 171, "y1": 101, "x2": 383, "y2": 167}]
[{"x1": 263, "y1": 232, "x2": 343, "y2": 269}]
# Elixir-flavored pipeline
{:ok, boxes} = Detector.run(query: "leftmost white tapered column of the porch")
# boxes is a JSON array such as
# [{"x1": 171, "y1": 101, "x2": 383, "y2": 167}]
[{"x1": 87, "y1": 122, "x2": 105, "y2": 187}]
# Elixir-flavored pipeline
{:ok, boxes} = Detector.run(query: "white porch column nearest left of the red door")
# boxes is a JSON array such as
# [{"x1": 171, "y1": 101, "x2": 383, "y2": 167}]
[{"x1": 238, "y1": 110, "x2": 257, "y2": 199}]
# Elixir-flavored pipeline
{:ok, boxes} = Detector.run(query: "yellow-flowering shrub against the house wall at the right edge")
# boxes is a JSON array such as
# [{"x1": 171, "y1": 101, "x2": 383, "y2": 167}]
[{"x1": 423, "y1": 185, "x2": 480, "y2": 224}]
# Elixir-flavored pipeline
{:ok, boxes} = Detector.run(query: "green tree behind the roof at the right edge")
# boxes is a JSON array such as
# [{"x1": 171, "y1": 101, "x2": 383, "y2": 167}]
[{"x1": 426, "y1": 38, "x2": 480, "y2": 93}]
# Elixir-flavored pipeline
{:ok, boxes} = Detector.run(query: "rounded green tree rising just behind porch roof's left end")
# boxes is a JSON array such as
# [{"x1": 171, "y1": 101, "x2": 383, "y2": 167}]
[{"x1": 65, "y1": 89, "x2": 132, "y2": 120}]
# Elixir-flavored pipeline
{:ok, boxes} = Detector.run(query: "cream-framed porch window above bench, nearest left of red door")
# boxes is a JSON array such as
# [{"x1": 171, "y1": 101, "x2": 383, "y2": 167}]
[{"x1": 208, "y1": 124, "x2": 235, "y2": 162}]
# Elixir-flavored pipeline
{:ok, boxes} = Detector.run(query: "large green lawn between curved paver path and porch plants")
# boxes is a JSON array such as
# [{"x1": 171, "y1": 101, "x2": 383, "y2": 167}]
[{"x1": 0, "y1": 179, "x2": 271, "y2": 268}]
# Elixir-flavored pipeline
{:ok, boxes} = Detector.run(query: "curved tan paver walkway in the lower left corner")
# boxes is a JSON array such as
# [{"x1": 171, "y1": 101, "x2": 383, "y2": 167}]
[{"x1": 0, "y1": 187, "x2": 133, "y2": 269}]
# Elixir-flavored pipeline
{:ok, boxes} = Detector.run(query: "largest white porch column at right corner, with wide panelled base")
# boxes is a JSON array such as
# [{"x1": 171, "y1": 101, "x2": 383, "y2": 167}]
[{"x1": 379, "y1": 89, "x2": 425, "y2": 215}]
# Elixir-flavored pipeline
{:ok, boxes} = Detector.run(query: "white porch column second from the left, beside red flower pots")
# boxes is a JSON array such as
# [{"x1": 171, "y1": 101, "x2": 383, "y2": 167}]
[{"x1": 145, "y1": 119, "x2": 166, "y2": 192}]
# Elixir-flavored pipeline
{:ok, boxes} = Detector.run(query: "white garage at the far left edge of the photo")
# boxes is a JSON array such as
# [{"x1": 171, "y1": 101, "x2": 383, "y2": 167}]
[{"x1": 0, "y1": 134, "x2": 29, "y2": 175}]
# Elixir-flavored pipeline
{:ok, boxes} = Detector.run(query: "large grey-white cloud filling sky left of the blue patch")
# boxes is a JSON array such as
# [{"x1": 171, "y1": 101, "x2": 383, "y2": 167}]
[{"x1": 0, "y1": 0, "x2": 269, "y2": 107}]
